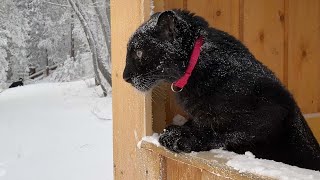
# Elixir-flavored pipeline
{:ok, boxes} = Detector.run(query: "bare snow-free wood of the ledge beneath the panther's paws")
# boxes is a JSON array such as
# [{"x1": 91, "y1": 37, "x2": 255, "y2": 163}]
[{"x1": 141, "y1": 141, "x2": 272, "y2": 180}]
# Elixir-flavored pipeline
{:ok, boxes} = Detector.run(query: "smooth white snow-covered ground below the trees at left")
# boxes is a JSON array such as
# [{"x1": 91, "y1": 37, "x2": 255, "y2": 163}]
[{"x1": 0, "y1": 80, "x2": 113, "y2": 180}]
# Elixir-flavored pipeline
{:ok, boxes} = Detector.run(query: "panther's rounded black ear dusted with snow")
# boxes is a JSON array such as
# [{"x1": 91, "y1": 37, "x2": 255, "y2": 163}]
[{"x1": 157, "y1": 11, "x2": 177, "y2": 40}]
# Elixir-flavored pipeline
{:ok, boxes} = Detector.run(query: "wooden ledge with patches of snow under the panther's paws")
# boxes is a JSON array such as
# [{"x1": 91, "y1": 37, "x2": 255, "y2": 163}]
[{"x1": 138, "y1": 134, "x2": 320, "y2": 180}]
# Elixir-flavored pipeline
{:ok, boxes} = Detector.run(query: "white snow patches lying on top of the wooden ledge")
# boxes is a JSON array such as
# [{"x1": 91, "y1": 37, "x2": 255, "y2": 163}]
[{"x1": 142, "y1": 133, "x2": 320, "y2": 180}]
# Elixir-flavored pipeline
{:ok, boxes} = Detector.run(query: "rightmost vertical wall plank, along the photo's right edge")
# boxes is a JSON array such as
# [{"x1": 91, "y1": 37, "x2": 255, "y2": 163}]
[{"x1": 288, "y1": 0, "x2": 320, "y2": 113}]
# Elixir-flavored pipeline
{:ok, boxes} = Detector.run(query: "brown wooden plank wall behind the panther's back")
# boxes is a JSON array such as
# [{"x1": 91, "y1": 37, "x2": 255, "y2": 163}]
[{"x1": 155, "y1": 0, "x2": 320, "y2": 140}]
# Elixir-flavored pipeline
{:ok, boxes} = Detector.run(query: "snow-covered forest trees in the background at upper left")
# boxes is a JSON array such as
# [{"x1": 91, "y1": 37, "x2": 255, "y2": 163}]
[{"x1": 0, "y1": 0, "x2": 111, "y2": 91}]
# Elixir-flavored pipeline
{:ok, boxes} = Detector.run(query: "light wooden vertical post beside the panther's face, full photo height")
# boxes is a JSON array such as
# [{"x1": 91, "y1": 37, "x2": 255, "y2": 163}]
[{"x1": 110, "y1": 0, "x2": 152, "y2": 179}]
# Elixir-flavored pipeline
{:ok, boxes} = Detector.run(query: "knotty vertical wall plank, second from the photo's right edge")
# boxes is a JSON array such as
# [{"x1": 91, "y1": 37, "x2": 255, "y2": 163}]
[{"x1": 243, "y1": 0, "x2": 285, "y2": 80}]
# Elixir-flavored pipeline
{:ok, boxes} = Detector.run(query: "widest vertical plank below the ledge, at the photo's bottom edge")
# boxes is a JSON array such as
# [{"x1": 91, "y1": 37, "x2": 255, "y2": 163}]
[{"x1": 166, "y1": 158, "x2": 201, "y2": 180}]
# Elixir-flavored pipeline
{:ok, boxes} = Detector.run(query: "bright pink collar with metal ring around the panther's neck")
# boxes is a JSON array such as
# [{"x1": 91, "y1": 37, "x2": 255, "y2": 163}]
[{"x1": 171, "y1": 36, "x2": 203, "y2": 92}]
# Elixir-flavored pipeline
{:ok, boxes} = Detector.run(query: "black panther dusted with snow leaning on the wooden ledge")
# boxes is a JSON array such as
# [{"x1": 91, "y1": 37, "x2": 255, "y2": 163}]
[{"x1": 123, "y1": 10, "x2": 320, "y2": 170}]
